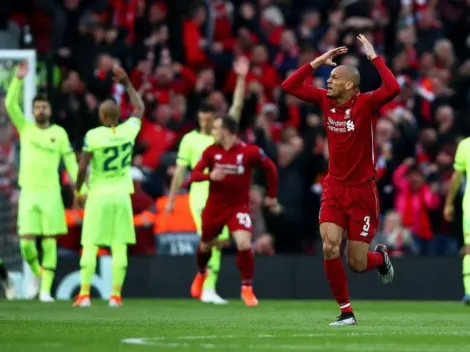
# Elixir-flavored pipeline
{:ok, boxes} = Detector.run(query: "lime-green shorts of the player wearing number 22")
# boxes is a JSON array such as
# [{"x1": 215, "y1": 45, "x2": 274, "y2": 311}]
[{"x1": 81, "y1": 192, "x2": 135, "y2": 247}]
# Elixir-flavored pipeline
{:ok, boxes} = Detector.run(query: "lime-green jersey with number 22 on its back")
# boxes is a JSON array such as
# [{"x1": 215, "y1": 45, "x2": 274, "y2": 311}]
[{"x1": 83, "y1": 117, "x2": 141, "y2": 193}]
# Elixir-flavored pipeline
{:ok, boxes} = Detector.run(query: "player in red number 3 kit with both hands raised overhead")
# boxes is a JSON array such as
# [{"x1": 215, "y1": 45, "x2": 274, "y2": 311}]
[{"x1": 282, "y1": 34, "x2": 400, "y2": 326}]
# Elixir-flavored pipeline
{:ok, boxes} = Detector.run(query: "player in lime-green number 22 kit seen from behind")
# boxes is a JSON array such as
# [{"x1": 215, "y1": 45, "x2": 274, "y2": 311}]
[{"x1": 74, "y1": 66, "x2": 144, "y2": 307}]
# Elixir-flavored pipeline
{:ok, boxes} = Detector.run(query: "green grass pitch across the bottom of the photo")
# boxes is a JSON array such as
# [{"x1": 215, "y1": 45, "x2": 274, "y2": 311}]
[{"x1": 0, "y1": 300, "x2": 470, "y2": 352}]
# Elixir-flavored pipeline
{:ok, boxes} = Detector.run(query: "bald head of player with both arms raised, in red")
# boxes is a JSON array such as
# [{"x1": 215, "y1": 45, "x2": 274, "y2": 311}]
[{"x1": 327, "y1": 65, "x2": 361, "y2": 101}]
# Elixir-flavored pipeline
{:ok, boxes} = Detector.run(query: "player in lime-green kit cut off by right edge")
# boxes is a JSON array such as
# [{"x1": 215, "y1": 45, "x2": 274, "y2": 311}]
[{"x1": 444, "y1": 138, "x2": 470, "y2": 305}]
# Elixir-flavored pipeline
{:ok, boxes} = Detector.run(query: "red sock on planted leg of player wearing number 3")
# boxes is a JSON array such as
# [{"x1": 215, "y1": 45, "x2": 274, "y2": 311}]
[{"x1": 324, "y1": 257, "x2": 352, "y2": 313}]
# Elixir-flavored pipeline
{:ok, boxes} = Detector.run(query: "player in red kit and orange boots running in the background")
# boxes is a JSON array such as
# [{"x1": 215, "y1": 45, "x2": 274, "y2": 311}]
[{"x1": 191, "y1": 116, "x2": 279, "y2": 307}]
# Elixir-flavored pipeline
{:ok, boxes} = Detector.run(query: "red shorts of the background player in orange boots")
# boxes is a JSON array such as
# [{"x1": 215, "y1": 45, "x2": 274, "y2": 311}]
[{"x1": 201, "y1": 206, "x2": 253, "y2": 242}]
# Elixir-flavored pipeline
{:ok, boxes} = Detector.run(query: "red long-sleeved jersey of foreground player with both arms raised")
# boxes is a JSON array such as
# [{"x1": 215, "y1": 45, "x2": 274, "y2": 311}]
[{"x1": 282, "y1": 57, "x2": 400, "y2": 184}]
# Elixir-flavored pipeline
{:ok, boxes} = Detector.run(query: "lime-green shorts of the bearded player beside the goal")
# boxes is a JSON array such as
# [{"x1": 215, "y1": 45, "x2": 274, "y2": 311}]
[{"x1": 18, "y1": 189, "x2": 67, "y2": 236}]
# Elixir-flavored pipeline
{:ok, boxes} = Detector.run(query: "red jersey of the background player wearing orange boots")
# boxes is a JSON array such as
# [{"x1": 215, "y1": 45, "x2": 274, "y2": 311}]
[{"x1": 191, "y1": 140, "x2": 277, "y2": 208}]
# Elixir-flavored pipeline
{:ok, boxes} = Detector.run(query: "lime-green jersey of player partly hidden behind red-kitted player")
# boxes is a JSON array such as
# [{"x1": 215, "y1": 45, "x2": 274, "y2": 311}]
[{"x1": 176, "y1": 130, "x2": 214, "y2": 193}]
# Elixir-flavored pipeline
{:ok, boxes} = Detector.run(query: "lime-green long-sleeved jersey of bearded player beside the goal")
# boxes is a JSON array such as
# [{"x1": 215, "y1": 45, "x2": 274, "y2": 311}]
[{"x1": 5, "y1": 77, "x2": 78, "y2": 191}]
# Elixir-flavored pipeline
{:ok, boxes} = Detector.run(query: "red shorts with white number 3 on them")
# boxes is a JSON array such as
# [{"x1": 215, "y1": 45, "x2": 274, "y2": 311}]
[{"x1": 320, "y1": 177, "x2": 379, "y2": 243}]
